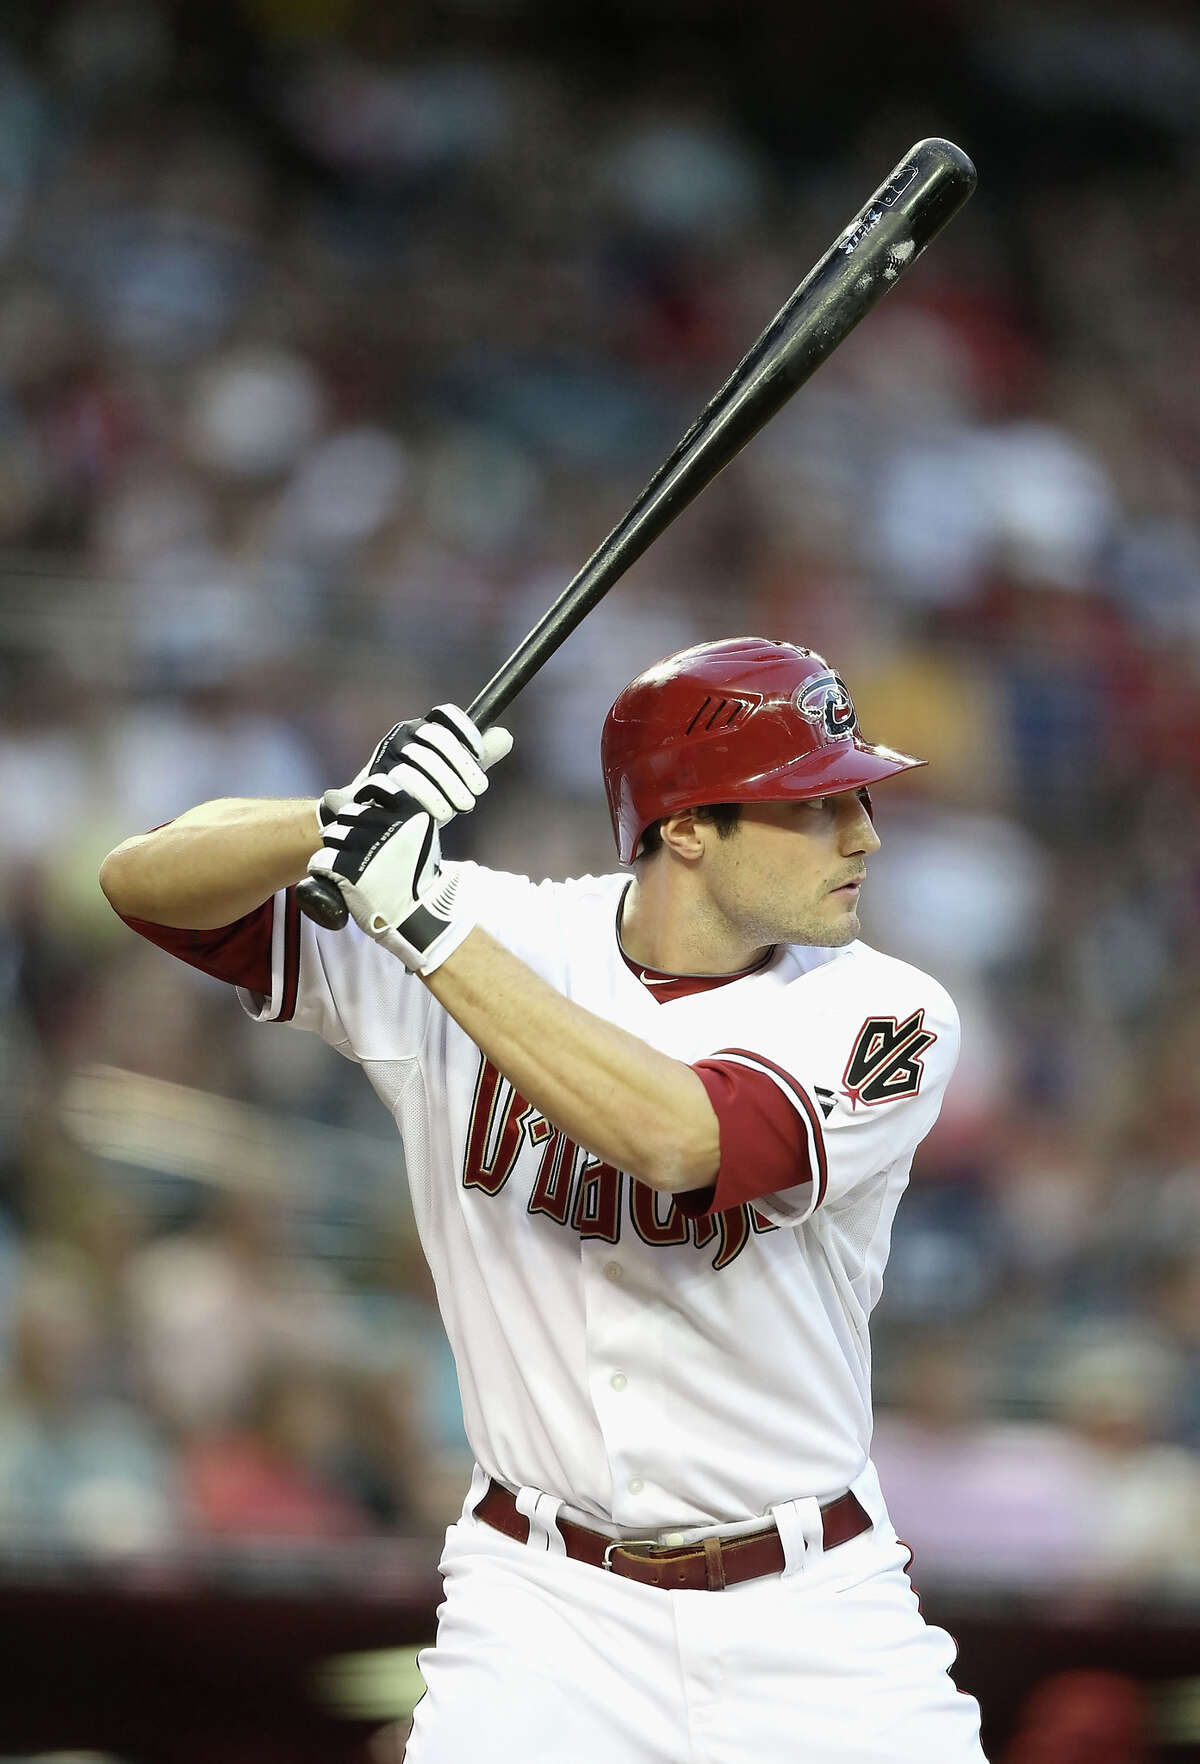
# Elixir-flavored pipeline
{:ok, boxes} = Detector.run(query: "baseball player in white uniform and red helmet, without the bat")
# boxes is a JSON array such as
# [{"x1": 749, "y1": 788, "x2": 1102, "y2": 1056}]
[{"x1": 102, "y1": 637, "x2": 983, "y2": 1764}]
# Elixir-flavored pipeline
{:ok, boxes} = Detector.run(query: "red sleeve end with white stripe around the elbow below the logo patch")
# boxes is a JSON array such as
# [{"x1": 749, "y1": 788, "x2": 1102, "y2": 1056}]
[{"x1": 674, "y1": 1050, "x2": 824, "y2": 1219}]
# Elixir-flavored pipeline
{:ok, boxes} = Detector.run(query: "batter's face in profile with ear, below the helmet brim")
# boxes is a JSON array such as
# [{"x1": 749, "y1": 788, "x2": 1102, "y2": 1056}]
[{"x1": 706, "y1": 790, "x2": 879, "y2": 949}]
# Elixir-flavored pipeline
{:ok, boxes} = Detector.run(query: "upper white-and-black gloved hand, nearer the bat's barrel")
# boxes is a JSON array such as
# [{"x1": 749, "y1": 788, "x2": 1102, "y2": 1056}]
[{"x1": 318, "y1": 704, "x2": 512, "y2": 827}]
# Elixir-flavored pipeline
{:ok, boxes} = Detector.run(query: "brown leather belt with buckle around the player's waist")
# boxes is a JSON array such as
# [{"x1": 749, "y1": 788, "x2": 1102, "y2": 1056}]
[{"x1": 475, "y1": 1482, "x2": 872, "y2": 1593}]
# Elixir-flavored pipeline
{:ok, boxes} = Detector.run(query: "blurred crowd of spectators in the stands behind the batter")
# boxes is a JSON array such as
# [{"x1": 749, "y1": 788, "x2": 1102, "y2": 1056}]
[{"x1": 0, "y1": 0, "x2": 1200, "y2": 1598}]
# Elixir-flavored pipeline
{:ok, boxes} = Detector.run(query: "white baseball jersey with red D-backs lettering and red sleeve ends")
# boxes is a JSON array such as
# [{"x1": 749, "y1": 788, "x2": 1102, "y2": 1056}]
[{"x1": 240, "y1": 864, "x2": 958, "y2": 1536}]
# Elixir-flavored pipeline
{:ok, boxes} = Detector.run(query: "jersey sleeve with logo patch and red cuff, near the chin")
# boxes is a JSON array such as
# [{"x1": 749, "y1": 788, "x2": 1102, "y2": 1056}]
[{"x1": 676, "y1": 958, "x2": 958, "y2": 1226}]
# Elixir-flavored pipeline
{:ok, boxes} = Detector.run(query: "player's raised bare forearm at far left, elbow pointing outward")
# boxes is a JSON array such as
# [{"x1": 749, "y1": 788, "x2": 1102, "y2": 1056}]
[{"x1": 101, "y1": 797, "x2": 321, "y2": 931}]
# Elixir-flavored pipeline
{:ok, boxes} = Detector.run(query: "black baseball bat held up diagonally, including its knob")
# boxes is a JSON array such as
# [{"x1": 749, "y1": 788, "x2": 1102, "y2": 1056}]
[{"x1": 296, "y1": 138, "x2": 976, "y2": 930}]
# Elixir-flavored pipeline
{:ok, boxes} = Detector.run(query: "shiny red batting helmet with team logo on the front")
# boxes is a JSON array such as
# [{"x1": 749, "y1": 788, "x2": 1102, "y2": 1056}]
[{"x1": 600, "y1": 637, "x2": 925, "y2": 864}]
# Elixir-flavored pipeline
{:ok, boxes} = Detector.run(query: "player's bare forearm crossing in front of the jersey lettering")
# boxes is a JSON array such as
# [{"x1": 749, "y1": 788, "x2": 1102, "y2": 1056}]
[{"x1": 425, "y1": 928, "x2": 720, "y2": 1192}]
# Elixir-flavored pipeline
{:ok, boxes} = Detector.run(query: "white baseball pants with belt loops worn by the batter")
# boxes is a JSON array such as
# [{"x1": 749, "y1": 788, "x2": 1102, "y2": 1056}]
[{"x1": 406, "y1": 1466, "x2": 986, "y2": 1764}]
